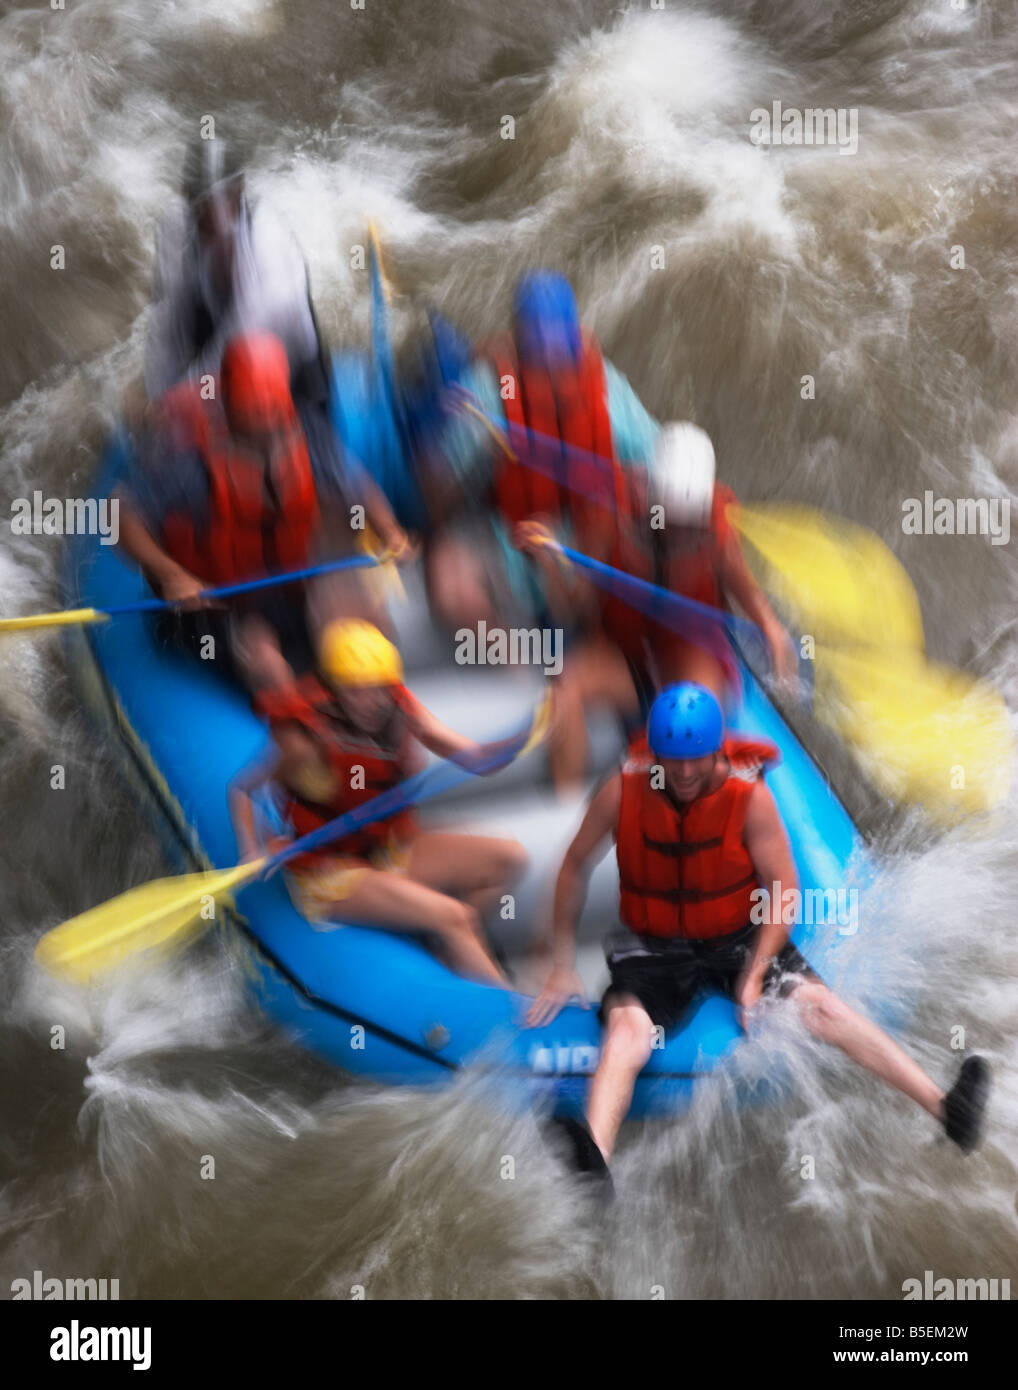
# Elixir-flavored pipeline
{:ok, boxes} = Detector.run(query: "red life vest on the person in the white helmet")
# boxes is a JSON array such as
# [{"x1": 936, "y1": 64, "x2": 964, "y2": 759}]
[{"x1": 601, "y1": 470, "x2": 737, "y2": 663}]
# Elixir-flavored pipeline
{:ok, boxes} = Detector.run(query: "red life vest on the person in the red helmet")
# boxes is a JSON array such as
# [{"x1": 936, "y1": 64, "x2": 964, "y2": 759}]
[{"x1": 161, "y1": 382, "x2": 318, "y2": 584}]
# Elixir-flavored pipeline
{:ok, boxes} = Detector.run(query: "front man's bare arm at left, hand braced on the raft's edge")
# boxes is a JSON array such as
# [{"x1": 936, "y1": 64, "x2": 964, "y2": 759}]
[{"x1": 527, "y1": 774, "x2": 622, "y2": 1027}]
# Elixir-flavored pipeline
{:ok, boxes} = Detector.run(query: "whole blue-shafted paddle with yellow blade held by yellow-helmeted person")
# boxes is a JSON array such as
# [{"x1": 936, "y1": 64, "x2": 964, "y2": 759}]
[{"x1": 35, "y1": 696, "x2": 549, "y2": 984}]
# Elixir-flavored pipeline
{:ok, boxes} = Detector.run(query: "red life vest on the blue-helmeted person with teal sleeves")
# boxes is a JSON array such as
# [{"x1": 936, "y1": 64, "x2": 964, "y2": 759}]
[{"x1": 490, "y1": 335, "x2": 623, "y2": 528}]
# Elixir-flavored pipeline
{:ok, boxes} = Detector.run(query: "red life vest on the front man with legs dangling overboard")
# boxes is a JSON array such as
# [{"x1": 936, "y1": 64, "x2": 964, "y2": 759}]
[{"x1": 616, "y1": 737, "x2": 779, "y2": 941}]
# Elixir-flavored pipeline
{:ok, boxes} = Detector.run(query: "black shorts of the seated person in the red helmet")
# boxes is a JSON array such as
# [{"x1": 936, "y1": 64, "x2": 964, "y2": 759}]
[{"x1": 157, "y1": 585, "x2": 314, "y2": 685}]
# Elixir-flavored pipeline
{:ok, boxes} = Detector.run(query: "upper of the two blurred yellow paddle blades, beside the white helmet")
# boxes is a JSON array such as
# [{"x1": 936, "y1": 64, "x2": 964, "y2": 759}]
[{"x1": 727, "y1": 503, "x2": 923, "y2": 651}]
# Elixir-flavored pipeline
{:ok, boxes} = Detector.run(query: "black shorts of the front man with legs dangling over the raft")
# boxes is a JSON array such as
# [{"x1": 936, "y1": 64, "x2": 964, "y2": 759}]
[{"x1": 599, "y1": 924, "x2": 821, "y2": 1031}]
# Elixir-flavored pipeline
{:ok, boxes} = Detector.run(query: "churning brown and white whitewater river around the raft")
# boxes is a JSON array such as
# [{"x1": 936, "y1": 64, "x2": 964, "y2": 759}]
[{"x1": 0, "y1": 0, "x2": 1018, "y2": 1298}]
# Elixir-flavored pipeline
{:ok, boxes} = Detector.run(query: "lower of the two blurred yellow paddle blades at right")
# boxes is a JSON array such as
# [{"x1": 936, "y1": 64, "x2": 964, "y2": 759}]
[{"x1": 816, "y1": 648, "x2": 1014, "y2": 821}]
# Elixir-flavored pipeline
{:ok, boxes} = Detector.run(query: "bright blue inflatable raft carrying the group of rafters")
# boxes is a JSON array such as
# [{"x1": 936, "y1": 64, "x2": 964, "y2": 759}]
[{"x1": 59, "y1": 443, "x2": 861, "y2": 1115}]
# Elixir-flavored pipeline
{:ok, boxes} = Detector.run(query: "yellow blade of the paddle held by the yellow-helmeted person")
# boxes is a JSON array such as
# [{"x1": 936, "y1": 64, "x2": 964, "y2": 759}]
[{"x1": 35, "y1": 859, "x2": 267, "y2": 984}]
